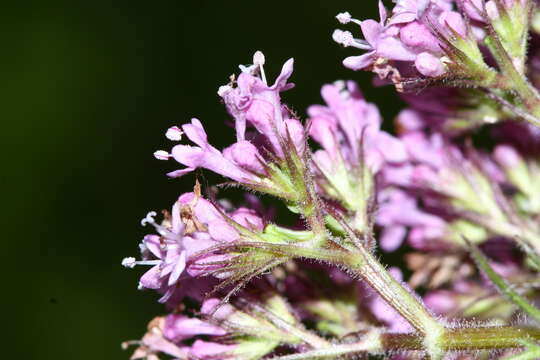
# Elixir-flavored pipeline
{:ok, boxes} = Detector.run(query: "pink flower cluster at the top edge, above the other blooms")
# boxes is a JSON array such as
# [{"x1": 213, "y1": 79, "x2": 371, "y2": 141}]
[{"x1": 332, "y1": 0, "x2": 476, "y2": 78}]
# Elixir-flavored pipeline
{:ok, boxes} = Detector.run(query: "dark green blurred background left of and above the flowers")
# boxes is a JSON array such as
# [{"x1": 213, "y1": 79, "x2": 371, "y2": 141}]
[{"x1": 4, "y1": 0, "x2": 400, "y2": 360}]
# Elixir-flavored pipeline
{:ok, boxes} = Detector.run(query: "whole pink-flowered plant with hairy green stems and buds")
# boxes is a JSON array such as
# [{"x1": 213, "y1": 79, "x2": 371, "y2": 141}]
[{"x1": 122, "y1": 0, "x2": 540, "y2": 360}]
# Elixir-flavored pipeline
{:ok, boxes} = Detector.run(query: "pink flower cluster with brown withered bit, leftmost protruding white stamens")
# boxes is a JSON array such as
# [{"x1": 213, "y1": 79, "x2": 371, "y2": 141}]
[{"x1": 122, "y1": 193, "x2": 264, "y2": 302}]
